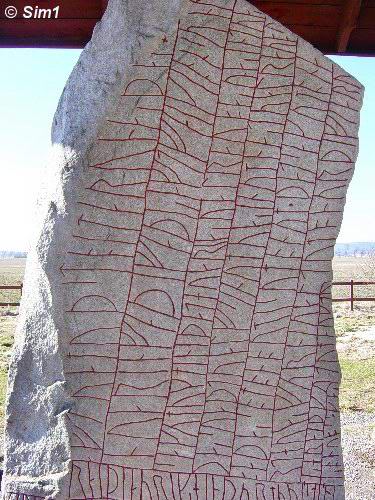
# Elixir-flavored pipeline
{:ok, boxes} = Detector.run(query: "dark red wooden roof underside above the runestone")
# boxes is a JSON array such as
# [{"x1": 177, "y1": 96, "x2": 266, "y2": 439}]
[{"x1": 0, "y1": 0, "x2": 375, "y2": 56}]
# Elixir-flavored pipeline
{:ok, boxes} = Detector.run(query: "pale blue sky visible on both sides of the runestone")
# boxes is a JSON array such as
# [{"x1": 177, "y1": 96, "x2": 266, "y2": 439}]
[{"x1": 0, "y1": 49, "x2": 375, "y2": 250}]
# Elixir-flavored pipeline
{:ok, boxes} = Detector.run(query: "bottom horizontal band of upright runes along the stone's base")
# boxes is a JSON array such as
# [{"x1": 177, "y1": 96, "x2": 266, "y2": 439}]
[{"x1": 52, "y1": 461, "x2": 345, "y2": 500}]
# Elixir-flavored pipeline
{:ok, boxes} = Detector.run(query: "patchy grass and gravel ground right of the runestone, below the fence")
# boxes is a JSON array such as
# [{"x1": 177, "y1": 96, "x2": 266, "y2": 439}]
[{"x1": 335, "y1": 307, "x2": 375, "y2": 500}]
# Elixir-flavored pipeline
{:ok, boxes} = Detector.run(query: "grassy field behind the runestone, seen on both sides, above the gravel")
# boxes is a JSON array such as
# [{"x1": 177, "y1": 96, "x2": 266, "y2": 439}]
[{"x1": 0, "y1": 257, "x2": 375, "y2": 452}]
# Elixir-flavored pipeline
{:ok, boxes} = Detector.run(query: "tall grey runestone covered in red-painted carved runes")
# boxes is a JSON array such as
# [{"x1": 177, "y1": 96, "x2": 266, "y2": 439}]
[{"x1": 0, "y1": 0, "x2": 362, "y2": 500}]
